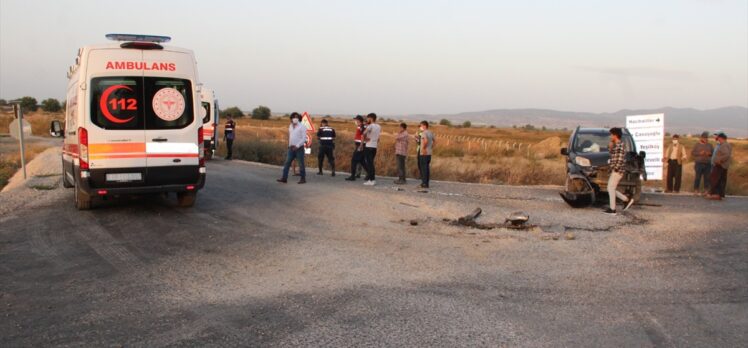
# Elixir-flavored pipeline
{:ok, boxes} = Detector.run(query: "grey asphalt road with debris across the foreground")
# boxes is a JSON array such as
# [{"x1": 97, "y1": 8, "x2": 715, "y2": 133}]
[{"x1": 0, "y1": 161, "x2": 748, "y2": 347}]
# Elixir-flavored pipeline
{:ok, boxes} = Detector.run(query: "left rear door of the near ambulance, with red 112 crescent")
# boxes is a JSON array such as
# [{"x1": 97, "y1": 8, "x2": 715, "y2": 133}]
[{"x1": 84, "y1": 48, "x2": 147, "y2": 188}]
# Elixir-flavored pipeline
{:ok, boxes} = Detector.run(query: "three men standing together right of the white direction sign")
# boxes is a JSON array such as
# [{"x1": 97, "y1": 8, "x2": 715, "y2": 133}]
[{"x1": 662, "y1": 131, "x2": 732, "y2": 200}]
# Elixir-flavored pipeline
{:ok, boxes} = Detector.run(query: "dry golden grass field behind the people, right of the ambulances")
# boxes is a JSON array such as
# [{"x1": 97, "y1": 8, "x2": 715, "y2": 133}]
[{"x1": 219, "y1": 117, "x2": 748, "y2": 195}]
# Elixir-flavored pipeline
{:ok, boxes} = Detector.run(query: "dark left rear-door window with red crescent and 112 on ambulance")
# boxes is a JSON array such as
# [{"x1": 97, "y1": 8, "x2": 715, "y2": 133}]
[{"x1": 91, "y1": 76, "x2": 143, "y2": 130}]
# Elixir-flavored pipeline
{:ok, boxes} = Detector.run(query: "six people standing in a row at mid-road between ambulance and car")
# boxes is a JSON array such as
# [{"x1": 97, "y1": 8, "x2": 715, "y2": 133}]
[{"x1": 277, "y1": 112, "x2": 435, "y2": 188}]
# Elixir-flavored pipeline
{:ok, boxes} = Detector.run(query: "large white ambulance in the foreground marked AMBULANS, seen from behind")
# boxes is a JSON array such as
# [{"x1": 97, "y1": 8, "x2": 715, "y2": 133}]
[{"x1": 53, "y1": 34, "x2": 205, "y2": 209}]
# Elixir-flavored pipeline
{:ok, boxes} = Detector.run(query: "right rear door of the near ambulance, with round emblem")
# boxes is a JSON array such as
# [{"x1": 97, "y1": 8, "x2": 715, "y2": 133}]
[{"x1": 143, "y1": 50, "x2": 202, "y2": 186}]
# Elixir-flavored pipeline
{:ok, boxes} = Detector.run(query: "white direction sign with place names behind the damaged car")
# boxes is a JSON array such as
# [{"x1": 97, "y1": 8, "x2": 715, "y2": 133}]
[{"x1": 626, "y1": 114, "x2": 665, "y2": 180}]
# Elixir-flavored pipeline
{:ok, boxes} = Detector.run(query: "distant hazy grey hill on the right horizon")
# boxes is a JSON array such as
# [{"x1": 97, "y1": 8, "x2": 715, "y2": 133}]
[{"x1": 405, "y1": 106, "x2": 748, "y2": 138}]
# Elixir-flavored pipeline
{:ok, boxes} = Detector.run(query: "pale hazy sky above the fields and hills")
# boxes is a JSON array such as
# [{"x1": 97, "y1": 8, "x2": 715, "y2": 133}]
[{"x1": 0, "y1": 0, "x2": 748, "y2": 115}]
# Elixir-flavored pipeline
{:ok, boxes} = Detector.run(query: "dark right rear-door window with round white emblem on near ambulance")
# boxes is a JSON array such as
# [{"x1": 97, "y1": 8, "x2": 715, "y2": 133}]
[{"x1": 143, "y1": 77, "x2": 195, "y2": 129}]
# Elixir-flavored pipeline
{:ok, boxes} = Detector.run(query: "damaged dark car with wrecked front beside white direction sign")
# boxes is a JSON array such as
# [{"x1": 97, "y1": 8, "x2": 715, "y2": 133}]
[{"x1": 561, "y1": 127, "x2": 647, "y2": 208}]
